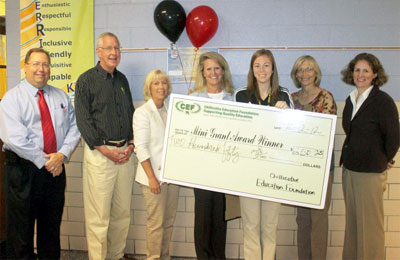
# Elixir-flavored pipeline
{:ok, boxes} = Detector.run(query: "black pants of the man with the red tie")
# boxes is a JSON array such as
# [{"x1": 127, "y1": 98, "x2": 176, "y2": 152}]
[{"x1": 4, "y1": 152, "x2": 66, "y2": 259}]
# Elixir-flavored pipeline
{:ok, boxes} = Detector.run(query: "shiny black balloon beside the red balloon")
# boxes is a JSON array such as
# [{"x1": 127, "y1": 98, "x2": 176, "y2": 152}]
[{"x1": 154, "y1": 0, "x2": 186, "y2": 43}]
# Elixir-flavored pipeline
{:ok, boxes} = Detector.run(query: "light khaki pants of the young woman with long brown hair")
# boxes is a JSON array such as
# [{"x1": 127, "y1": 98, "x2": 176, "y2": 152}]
[{"x1": 240, "y1": 197, "x2": 281, "y2": 260}]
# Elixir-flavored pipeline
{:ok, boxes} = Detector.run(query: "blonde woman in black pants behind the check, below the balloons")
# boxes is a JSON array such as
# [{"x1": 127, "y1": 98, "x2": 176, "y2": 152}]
[{"x1": 191, "y1": 52, "x2": 233, "y2": 259}]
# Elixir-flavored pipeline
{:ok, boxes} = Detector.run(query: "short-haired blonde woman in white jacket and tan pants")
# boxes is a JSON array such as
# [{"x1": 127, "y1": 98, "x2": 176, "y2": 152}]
[{"x1": 133, "y1": 70, "x2": 179, "y2": 259}]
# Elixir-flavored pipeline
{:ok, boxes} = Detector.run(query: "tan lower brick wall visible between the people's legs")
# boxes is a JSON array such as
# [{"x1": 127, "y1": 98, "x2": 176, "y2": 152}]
[{"x1": 61, "y1": 102, "x2": 400, "y2": 260}]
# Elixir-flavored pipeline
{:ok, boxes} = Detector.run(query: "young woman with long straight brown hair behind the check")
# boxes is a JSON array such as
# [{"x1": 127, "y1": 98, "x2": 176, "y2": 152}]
[{"x1": 235, "y1": 49, "x2": 293, "y2": 260}]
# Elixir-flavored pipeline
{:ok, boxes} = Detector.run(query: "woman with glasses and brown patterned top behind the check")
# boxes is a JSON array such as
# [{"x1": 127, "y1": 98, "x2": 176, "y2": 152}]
[{"x1": 290, "y1": 55, "x2": 336, "y2": 259}]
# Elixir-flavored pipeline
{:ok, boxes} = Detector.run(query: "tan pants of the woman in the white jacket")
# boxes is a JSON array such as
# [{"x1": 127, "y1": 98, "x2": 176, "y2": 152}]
[{"x1": 141, "y1": 184, "x2": 179, "y2": 260}]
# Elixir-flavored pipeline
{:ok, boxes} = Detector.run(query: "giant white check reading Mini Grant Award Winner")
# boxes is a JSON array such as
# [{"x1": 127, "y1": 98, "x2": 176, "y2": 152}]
[{"x1": 161, "y1": 94, "x2": 336, "y2": 208}]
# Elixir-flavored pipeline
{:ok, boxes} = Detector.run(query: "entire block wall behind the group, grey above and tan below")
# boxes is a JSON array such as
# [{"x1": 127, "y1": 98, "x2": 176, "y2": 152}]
[{"x1": 6, "y1": 0, "x2": 400, "y2": 259}]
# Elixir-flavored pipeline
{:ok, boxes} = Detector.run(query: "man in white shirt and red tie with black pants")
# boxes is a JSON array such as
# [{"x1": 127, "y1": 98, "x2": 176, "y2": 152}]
[{"x1": 0, "y1": 48, "x2": 80, "y2": 259}]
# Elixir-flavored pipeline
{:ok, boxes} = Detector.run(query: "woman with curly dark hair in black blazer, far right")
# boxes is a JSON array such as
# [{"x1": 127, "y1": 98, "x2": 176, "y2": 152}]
[{"x1": 340, "y1": 53, "x2": 400, "y2": 260}]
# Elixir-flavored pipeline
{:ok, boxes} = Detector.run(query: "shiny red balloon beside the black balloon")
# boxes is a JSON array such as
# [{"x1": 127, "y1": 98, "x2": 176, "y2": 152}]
[{"x1": 186, "y1": 5, "x2": 218, "y2": 48}]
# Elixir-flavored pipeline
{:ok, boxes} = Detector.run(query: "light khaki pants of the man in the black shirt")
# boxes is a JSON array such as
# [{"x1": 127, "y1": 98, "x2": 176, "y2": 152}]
[{"x1": 83, "y1": 144, "x2": 134, "y2": 260}]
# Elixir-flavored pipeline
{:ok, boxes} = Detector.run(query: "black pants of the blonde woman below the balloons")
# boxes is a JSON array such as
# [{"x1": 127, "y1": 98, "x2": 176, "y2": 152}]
[{"x1": 194, "y1": 189, "x2": 226, "y2": 259}]
